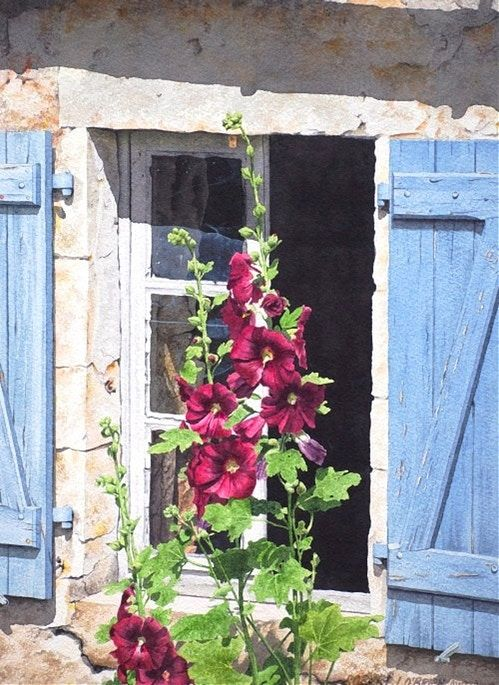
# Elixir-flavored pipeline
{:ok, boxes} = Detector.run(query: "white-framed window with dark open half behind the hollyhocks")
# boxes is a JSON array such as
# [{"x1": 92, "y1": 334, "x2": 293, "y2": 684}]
[{"x1": 123, "y1": 132, "x2": 374, "y2": 610}]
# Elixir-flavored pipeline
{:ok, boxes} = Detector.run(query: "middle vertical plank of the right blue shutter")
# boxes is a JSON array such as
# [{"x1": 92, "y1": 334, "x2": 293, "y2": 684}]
[{"x1": 433, "y1": 141, "x2": 479, "y2": 653}]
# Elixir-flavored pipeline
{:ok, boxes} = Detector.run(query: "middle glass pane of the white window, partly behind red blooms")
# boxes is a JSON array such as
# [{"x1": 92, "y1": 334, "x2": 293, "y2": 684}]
[{"x1": 150, "y1": 295, "x2": 230, "y2": 414}]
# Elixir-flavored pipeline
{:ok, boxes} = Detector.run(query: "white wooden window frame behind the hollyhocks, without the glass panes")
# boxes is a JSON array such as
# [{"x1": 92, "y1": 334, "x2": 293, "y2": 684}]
[{"x1": 118, "y1": 131, "x2": 370, "y2": 619}]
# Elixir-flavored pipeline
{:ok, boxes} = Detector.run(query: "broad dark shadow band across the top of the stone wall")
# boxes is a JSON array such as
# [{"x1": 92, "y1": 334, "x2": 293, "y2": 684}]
[{"x1": 0, "y1": 0, "x2": 498, "y2": 117}]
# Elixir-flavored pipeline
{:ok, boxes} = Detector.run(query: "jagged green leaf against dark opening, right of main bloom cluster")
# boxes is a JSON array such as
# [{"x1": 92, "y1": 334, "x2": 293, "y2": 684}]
[{"x1": 298, "y1": 466, "x2": 361, "y2": 511}]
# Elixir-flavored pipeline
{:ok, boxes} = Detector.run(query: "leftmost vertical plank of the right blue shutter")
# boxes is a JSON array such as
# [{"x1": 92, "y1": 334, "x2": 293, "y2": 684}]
[{"x1": 386, "y1": 141, "x2": 435, "y2": 647}]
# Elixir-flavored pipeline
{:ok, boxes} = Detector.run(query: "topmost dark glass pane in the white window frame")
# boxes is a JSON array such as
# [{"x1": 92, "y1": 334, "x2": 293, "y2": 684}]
[{"x1": 151, "y1": 155, "x2": 245, "y2": 281}]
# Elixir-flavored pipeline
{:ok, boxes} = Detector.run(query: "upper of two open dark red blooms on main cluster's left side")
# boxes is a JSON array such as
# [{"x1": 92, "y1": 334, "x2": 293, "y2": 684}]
[{"x1": 185, "y1": 383, "x2": 237, "y2": 438}]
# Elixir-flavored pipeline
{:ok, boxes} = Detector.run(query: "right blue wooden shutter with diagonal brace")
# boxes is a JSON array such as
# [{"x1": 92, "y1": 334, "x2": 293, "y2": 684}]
[{"x1": 386, "y1": 141, "x2": 499, "y2": 657}]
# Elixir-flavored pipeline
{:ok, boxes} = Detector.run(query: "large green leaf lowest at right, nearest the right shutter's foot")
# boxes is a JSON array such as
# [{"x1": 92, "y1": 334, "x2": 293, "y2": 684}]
[{"x1": 300, "y1": 602, "x2": 382, "y2": 663}]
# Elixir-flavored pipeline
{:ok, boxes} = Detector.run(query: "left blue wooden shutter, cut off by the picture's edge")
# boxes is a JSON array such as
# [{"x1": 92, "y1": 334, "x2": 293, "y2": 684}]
[{"x1": 0, "y1": 132, "x2": 53, "y2": 599}]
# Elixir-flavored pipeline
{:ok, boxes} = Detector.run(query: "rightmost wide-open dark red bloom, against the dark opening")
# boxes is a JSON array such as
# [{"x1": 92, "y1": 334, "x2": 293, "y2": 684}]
[{"x1": 261, "y1": 373, "x2": 324, "y2": 433}]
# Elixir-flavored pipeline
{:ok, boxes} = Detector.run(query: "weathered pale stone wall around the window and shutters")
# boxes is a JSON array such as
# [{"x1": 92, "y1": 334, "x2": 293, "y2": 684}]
[{"x1": 0, "y1": 0, "x2": 499, "y2": 685}]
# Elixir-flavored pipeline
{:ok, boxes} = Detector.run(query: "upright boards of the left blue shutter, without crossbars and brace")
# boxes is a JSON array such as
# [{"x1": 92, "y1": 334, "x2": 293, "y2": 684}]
[{"x1": 0, "y1": 132, "x2": 53, "y2": 599}]
